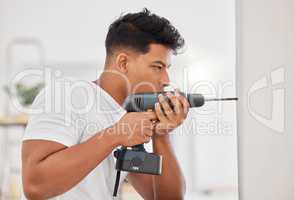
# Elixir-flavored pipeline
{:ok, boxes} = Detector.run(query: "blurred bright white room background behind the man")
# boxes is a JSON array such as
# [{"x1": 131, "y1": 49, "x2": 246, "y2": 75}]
[{"x1": 0, "y1": 0, "x2": 238, "y2": 200}]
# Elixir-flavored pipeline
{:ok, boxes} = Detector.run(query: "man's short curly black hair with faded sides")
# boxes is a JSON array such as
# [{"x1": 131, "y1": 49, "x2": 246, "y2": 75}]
[{"x1": 105, "y1": 8, "x2": 185, "y2": 55}]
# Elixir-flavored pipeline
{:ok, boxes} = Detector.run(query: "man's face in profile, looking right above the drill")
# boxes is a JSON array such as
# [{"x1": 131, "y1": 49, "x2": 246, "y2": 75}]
[{"x1": 127, "y1": 44, "x2": 172, "y2": 93}]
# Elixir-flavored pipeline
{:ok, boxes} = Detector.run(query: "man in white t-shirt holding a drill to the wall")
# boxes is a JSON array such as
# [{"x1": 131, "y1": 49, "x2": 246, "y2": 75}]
[{"x1": 22, "y1": 9, "x2": 189, "y2": 200}]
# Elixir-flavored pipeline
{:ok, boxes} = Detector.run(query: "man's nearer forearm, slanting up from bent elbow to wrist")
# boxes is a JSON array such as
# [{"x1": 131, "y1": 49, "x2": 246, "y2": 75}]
[{"x1": 24, "y1": 128, "x2": 118, "y2": 200}]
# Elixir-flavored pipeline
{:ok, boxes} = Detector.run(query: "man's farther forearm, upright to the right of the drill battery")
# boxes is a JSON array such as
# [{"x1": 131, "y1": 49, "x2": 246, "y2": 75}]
[{"x1": 153, "y1": 135, "x2": 186, "y2": 200}]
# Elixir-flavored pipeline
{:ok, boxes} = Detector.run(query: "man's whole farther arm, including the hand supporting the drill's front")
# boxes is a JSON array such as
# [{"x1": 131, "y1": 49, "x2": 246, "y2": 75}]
[{"x1": 128, "y1": 91, "x2": 190, "y2": 200}]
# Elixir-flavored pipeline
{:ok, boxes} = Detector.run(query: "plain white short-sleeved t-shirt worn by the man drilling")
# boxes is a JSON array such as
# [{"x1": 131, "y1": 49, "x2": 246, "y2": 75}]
[{"x1": 22, "y1": 78, "x2": 127, "y2": 200}]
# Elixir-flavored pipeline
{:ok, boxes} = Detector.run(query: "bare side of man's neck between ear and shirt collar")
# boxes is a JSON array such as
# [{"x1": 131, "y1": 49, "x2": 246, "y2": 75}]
[{"x1": 94, "y1": 72, "x2": 127, "y2": 105}]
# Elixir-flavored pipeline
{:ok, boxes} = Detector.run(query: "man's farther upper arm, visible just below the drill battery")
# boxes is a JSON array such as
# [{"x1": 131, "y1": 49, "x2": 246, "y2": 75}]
[{"x1": 127, "y1": 173, "x2": 154, "y2": 200}]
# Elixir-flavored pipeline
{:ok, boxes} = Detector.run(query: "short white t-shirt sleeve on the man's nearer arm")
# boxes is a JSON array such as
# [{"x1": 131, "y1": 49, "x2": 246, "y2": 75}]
[{"x1": 23, "y1": 89, "x2": 81, "y2": 146}]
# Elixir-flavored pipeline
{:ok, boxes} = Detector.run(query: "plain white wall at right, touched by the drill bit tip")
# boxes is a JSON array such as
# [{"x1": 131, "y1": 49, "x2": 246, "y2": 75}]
[{"x1": 237, "y1": 0, "x2": 294, "y2": 200}]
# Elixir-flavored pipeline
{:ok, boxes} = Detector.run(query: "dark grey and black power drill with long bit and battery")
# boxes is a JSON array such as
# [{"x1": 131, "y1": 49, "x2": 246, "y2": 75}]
[{"x1": 113, "y1": 92, "x2": 238, "y2": 196}]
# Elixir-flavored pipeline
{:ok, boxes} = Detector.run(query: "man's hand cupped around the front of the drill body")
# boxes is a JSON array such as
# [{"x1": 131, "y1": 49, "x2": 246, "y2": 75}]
[{"x1": 155, "y1": 90, "x2": 190, "y2": 135}]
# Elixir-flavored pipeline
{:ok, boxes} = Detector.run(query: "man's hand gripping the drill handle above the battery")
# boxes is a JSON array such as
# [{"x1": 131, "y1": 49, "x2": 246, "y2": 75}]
[{"x1": 112, "y1": 112, "x2": 157, "y2": 147}]
